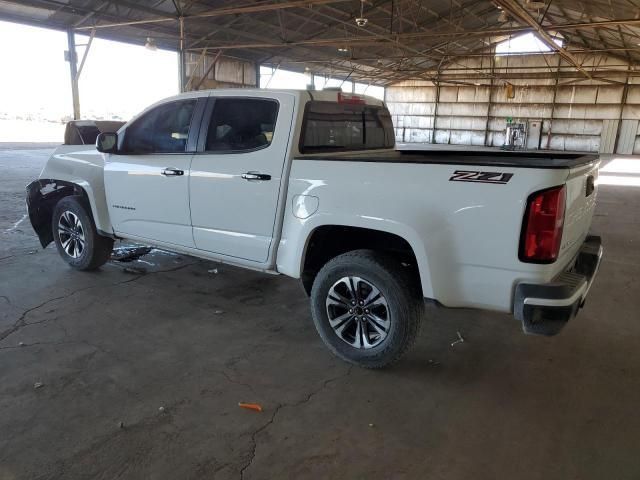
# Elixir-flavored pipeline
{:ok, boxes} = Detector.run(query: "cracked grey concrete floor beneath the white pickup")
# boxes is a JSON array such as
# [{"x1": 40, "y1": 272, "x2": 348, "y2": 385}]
[{"x1": 0, "y1": 147, "x2": 640, "y2": 480}]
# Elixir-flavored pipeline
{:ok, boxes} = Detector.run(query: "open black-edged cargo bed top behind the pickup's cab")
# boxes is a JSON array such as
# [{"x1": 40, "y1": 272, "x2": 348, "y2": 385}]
[{"x1": 295, "y1": 149, "x2": 598, "y2": 169}]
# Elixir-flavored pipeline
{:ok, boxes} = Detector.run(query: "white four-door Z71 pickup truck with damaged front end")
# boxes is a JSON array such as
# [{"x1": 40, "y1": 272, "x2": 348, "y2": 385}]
[{"x1": 27, "y1": 90, "x2": 602, "y2": 368}]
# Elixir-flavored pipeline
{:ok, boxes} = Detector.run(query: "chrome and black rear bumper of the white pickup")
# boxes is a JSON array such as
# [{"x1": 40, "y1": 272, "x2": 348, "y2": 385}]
[{"x1": 513, "y1": 236, "x2": 603, "y2": 335}]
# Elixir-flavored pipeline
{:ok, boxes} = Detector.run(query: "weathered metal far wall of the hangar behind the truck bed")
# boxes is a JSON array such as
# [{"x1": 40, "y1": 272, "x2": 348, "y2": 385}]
[{"x1": 387, "y1": 55, "x2": 640, "y2": 153}]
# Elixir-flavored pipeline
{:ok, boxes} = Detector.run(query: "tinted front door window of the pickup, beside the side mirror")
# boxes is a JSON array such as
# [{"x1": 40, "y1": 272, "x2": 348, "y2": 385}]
[{"x1": 123, "y1": 100, "x2": 196, "y2": 153}]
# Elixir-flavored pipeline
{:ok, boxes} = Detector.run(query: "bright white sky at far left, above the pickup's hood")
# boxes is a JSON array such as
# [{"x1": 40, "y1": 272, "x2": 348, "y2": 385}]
[{"x1": 0, "y1": 22, "x2": 178, "y2": 119}]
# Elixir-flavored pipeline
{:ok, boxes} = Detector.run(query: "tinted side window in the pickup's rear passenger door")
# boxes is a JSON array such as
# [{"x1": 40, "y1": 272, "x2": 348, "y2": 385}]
[{"x1": 205, "y1": 98, "x2": 278, "y2": 152}]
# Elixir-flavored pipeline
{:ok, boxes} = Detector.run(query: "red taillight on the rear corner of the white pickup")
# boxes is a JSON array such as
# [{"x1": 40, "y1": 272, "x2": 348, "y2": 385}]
[{"x1": 520, "y1": 185, "x2": 566, "y2": 263}]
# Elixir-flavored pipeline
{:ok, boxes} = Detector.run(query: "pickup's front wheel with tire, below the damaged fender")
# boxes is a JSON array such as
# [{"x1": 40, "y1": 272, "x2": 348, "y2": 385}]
[{"x1": 51, "y1": 196, "x2": 113, "y2": 270}]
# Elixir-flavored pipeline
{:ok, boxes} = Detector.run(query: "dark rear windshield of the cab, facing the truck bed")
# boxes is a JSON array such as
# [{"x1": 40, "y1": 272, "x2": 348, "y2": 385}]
[{"x1": 300, "y1": 101, "x2": 395, "y2": 153}]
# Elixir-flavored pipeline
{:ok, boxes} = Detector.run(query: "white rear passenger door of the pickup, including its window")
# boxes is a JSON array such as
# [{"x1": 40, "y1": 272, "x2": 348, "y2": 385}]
[{"x1": 190, "y1": 92, "x2": 295, "y2": 263}]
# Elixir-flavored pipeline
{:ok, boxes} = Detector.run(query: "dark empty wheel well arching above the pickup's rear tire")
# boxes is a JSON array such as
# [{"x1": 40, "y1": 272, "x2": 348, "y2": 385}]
[{"x1": 300, "y1": 225, "x2": 422, "y2": 295}]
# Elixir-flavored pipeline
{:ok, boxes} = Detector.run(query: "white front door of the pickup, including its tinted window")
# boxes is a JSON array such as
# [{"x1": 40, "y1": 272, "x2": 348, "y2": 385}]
[{"x1": 104, "y1": 98, "x2": 206, "y2": 247}]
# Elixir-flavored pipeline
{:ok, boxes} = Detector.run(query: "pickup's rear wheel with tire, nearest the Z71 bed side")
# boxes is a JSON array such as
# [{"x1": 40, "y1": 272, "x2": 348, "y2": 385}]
[{"x1": 311, "y1": 250, "x2": 424, "y2": 368}]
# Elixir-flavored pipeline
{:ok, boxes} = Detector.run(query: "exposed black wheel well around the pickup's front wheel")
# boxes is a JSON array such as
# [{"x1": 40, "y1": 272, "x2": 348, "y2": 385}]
[{"x1": 27, "y1": 179, "x2": 91, "y2": 248}]
